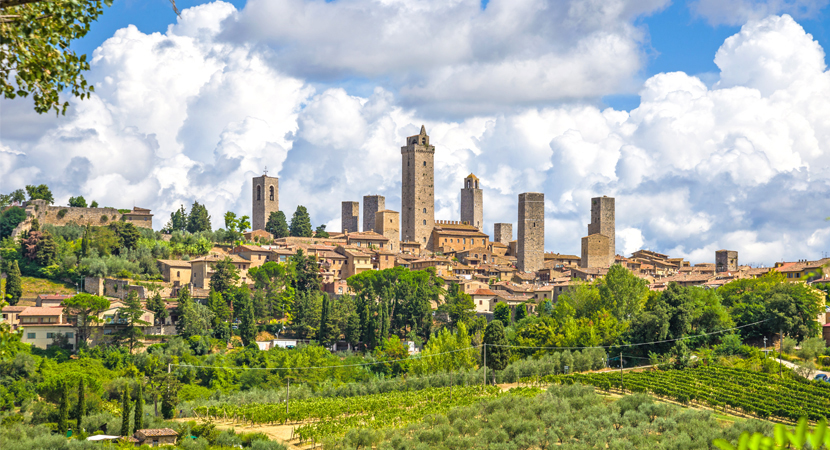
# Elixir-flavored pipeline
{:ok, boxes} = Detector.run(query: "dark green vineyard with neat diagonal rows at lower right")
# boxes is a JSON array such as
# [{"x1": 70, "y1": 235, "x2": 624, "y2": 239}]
[{"x1": 542, "y1": 366, "x2": 830, "y2": 421}]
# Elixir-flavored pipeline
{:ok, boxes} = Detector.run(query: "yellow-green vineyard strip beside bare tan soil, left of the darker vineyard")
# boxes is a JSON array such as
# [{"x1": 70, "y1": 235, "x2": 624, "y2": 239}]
[{"x1": 193, "y1": 386, "x2": 541, "y2": 442}]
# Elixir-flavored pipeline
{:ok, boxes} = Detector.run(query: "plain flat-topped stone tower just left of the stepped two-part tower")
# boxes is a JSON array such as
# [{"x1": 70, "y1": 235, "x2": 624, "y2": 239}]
[{"x1": 516, "y1": 192, "x2": 545, "y2": 272}]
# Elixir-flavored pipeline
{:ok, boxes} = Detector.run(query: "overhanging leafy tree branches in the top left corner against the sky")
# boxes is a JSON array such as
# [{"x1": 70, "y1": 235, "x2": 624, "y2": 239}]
[{"x1": 0, "y1": 0, "x2": 112, "y2": 114}]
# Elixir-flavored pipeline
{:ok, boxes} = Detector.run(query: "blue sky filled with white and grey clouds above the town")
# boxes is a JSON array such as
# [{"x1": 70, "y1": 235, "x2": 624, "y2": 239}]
[{"x1": 0, "y1": 0, "x2": 830, "y2": 265}]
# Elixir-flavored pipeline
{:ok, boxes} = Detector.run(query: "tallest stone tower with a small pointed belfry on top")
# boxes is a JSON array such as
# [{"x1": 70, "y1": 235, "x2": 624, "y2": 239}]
[{"x1": 401, "y1": 126, "x2": 435, "y2": 250}]
